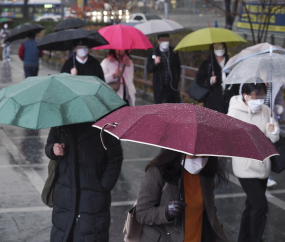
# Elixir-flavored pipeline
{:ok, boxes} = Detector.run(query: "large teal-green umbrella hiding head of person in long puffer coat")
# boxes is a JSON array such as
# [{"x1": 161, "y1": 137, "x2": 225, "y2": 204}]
[{"x1": 0, "y1": 73, "x2": 126, "y2": 130}]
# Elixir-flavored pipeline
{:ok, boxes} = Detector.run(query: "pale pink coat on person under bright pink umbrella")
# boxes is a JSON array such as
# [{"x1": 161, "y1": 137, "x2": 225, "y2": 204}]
[{"x1": 101, "y1": 56, "x2": 136, "y2": 106}]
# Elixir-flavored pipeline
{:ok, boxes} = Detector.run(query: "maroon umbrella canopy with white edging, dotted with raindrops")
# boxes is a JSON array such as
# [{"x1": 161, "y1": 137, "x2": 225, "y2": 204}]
[{"x1": 93, "y1": 104, "x2": 278, "y2": 161}]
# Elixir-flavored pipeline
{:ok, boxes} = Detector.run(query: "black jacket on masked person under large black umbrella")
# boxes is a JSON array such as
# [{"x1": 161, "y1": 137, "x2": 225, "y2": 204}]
[{"x1": 61, "y1": 55, "x2": 105, "y2": 81}]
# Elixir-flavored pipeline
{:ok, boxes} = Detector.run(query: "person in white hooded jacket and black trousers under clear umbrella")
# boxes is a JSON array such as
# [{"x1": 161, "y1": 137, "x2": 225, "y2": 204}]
[{"x1": 228, "y1": 78, "x2": 279, "y2": 242}]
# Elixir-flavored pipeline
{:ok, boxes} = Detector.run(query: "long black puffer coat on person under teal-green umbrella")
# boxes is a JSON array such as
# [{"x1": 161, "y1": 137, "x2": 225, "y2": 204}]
[{"x1": 45, "y1": 123, "x2": 123, "y2": 242}]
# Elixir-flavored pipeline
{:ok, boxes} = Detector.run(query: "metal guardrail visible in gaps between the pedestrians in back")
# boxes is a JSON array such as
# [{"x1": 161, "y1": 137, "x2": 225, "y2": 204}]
[{"x1": 44, "y1": 50, "x2": 198, "y2": 102}]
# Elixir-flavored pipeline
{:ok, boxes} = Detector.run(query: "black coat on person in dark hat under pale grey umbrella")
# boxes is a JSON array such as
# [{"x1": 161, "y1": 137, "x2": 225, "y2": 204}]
[{"x1": 147, "y1": 47, "x2": 181, "y2": 104}]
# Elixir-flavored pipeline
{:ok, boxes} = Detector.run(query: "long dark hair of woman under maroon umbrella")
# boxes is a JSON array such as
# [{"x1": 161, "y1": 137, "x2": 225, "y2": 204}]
[{"x1": 145, "y1": 149, "x2": 228, "y2": 187}]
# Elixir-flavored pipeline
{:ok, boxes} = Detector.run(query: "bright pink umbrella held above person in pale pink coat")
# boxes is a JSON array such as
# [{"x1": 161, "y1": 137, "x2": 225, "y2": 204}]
[{"x1": 93, "y1": 24, "x2": 153, "y2": 50}]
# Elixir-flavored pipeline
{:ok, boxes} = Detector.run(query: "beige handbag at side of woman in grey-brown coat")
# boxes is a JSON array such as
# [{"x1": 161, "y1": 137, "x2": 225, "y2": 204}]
[{"x1": 123, "y1": 182, "x2": 167, "y2": 242}]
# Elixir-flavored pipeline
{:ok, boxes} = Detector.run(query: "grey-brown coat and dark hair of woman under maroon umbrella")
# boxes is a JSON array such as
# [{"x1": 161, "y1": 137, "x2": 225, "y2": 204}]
[{"x1": 136, "y1": 150, "x2": 228, "y2": 242}]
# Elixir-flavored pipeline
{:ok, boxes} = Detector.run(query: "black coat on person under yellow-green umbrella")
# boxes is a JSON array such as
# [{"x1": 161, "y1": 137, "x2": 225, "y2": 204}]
[{"x1": 196, "y1": 57, "x2": 239, "y2": 114}]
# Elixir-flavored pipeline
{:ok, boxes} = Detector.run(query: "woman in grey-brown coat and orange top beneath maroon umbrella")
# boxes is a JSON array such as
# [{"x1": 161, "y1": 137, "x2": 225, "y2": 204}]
[{"x1": 135, "y1": 150, "x2": 228, "y2": 242}]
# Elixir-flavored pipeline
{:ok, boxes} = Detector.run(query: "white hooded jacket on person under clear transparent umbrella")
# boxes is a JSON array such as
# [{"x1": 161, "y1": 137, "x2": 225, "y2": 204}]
[{"x1": 228, "y1": 95, "x2": 279, "y2": 179}]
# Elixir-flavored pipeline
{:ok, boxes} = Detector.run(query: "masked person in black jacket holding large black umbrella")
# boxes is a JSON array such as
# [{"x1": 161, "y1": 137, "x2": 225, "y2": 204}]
[{"x1": 61, "y1": 40, "x2": 105, "y2": 81}]
